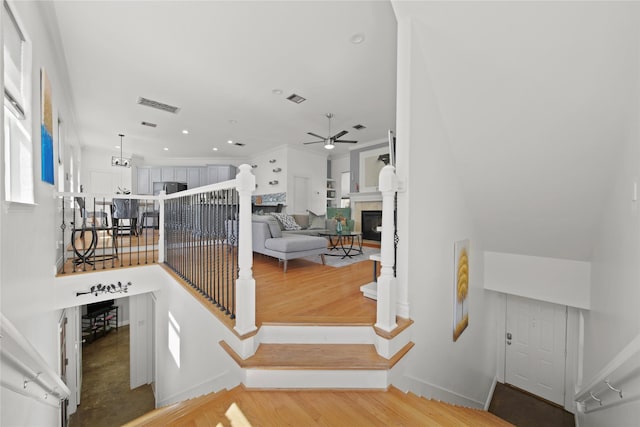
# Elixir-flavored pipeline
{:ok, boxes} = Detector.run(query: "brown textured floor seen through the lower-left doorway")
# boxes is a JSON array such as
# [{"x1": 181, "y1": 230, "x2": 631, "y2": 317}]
[{"x1": 69, "y1": 326, "x2": 154, "y2": 427}]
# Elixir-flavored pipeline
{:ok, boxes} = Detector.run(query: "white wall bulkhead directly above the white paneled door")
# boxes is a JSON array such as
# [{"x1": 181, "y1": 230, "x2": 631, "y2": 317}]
[{"x1": 484, "y1": 252, "x2": 591, "y2": 309}]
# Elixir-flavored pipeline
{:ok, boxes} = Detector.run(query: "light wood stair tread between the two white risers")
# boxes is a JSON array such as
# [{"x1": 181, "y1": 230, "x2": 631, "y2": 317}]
[{"x1": 220, "y1": 341, "x2": 413, "y2": 370}]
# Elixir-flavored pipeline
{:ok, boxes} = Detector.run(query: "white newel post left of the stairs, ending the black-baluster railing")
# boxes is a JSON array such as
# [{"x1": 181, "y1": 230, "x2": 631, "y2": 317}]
[{"x1": 235, "y1": 165, "x2": 256, "y2": 335}]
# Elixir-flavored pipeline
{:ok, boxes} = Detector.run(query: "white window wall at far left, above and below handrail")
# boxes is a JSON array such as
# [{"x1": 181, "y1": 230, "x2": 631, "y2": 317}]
[{"x1": 0, "y1": 2, "x2": 84, "y2": 425}]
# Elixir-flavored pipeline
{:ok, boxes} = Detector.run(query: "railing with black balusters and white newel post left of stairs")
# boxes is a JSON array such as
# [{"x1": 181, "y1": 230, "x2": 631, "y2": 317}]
[{"x1": 160, "y1": 165, "x2": 256, "y2": 335}]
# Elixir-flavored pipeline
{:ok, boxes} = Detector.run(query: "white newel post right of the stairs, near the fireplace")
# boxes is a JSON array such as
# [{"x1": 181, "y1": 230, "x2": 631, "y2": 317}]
[{"x1": 376, "y1": 165, "x2": 398, "y2": 332}]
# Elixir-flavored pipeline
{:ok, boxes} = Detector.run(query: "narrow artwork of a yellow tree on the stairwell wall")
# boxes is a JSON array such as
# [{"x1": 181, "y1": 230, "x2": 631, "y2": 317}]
[{"x1": 453, "y1": 239, "x2": 469, "y2": 341}]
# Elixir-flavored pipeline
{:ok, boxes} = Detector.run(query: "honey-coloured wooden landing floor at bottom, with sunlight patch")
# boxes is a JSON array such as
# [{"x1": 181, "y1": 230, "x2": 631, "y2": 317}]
[{"x1": 126, "y1": 386, "x2": 511, "y2": 427}]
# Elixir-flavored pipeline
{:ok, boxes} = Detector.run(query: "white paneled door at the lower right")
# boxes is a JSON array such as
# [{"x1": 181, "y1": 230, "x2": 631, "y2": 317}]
[{"x1": 505, "y1": 295, "x2": 567, "y2": 405}]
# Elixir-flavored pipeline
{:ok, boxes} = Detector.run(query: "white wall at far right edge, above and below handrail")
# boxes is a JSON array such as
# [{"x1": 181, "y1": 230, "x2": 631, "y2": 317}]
[{"x1": 579, "y1": 33, "x2": 640, "y2": 427}]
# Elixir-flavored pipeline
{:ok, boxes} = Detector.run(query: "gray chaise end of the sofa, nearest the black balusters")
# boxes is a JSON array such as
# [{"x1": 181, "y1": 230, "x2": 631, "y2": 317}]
[{"x1": 251, "y1": 215, "x2": 327, "y2": 273}]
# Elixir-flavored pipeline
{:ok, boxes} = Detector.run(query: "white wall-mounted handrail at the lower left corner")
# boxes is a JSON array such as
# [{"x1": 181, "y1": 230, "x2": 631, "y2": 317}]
[{"x1": 0, "y1": 313, "x2": 71, "y2": 407}]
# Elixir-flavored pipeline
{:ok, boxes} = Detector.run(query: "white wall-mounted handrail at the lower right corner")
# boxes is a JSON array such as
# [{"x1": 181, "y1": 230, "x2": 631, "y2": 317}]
[{"x1": 574, "y1": 334, "x2": 640, "y2": 413}]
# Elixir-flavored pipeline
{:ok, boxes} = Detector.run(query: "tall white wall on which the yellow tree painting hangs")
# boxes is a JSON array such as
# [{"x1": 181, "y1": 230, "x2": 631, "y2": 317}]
[{"x1": 394, "y1": 10, "x2": 497, "y2": 407}]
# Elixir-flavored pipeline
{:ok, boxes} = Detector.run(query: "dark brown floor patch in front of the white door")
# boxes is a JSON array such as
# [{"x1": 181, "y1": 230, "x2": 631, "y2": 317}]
[{"x1": 489, "y1": 383, "x2": 575, "y2": 427}]
